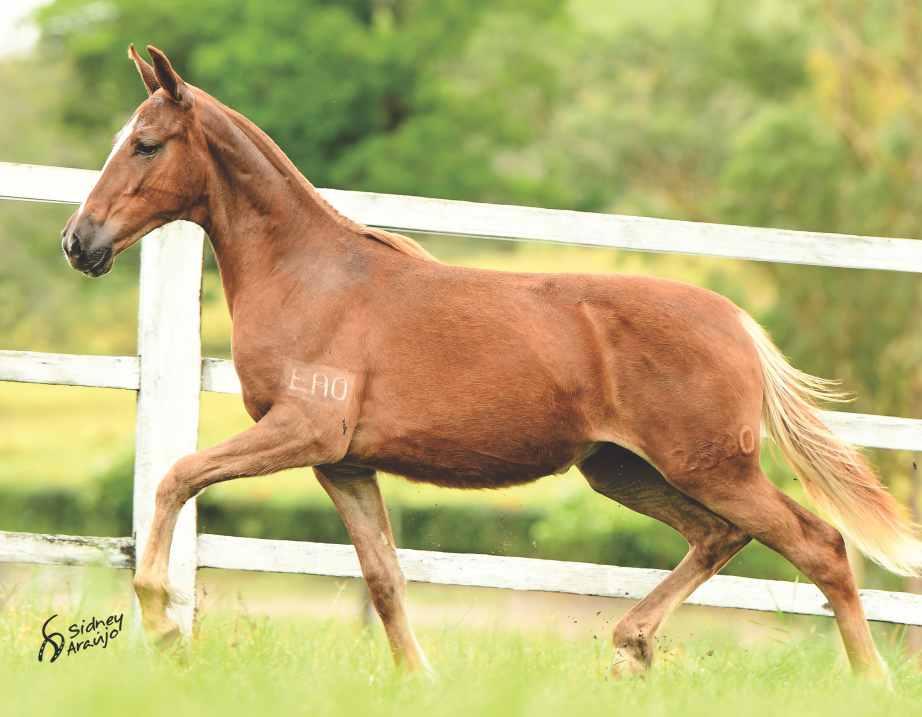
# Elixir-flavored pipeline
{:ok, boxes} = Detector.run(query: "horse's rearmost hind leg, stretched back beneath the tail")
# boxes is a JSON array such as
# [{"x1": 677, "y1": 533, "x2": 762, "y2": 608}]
[{"x1": 668, "y1": 456, "x2": 889, "y2": 683}]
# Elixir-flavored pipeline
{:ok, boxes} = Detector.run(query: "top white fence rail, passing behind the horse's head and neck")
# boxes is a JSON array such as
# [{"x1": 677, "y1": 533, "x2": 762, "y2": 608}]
[{"x1": 0, "y1": 162, "x2": 922, "y2": 274}]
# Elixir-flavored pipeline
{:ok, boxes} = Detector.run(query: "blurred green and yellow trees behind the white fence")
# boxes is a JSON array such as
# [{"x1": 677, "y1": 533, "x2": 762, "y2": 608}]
[{"x1": 0, "y1": 0, "x2": 922, "y2": 588}]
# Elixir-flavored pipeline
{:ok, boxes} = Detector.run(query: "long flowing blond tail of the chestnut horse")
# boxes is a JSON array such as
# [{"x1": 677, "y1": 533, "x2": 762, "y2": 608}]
[{"x1": 742, "y1": 312, "x2": 922, "y2": 576}]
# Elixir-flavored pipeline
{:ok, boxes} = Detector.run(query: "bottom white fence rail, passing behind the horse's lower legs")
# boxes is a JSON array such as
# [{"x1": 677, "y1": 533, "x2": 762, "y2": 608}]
[{"x1": 0, "y1": 533, "x2": 922, "y2": 625}]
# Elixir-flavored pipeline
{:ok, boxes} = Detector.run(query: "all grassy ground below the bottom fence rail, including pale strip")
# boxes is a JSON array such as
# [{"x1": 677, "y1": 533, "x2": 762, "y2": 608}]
[{"x1": 0, "y1": 568, "x2": 922, "y2": 717}]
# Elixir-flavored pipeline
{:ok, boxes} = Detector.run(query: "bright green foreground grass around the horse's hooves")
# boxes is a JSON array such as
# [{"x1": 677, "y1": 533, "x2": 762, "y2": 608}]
[{"x1": 7, "y1": 600, "x2": 922, "y2": 717}]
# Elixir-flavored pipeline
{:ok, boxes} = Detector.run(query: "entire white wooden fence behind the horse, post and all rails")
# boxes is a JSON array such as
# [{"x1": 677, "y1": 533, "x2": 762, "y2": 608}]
[{"x1": 0, "y1": 163, "x2": 922, "y2": 630}]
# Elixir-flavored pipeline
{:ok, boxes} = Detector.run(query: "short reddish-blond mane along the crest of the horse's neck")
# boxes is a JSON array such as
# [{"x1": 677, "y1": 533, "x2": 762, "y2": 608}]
[{"x1": 209, "y1": 95, "x2": 438, "y2": 262}]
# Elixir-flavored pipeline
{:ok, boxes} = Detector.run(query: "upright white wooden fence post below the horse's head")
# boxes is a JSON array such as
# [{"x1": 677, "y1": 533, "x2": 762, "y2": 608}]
[{"x1": 132, "y1": 222, "x2": 204, "y2": 634}]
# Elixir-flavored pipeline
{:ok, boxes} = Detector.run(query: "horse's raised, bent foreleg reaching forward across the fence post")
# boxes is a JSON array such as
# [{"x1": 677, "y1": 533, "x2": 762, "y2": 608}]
[{"x1": 134, "y1": 408, "x2": 319, "y2": 645}]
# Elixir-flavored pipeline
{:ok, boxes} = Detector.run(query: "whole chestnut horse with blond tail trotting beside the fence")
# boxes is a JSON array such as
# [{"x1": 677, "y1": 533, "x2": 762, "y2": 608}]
[{"x1": 62, "y1": 46, "x2": 922, "y2": 680}]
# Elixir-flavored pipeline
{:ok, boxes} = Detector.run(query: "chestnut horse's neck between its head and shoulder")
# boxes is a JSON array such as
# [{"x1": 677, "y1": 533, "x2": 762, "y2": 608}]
[{"x1": 203, "y1": 108, "x2": 359, "y2": 316}]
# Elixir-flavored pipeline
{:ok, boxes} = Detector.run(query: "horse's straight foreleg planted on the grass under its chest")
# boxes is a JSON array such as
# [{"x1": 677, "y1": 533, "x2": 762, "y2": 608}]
[{"x1": 314, "y1": 466, "x2": 432, "y2": 673}]
